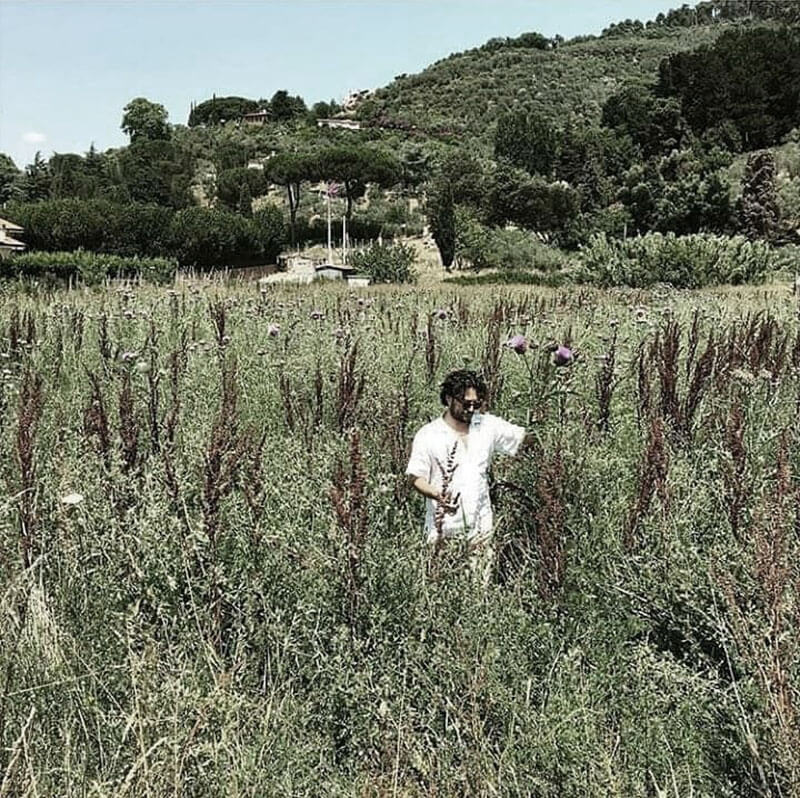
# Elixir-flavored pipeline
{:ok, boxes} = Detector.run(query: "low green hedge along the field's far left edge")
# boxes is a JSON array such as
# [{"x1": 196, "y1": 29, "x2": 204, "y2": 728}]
[{"x1": 0, "y1": 250, "x2": 178, "y2": 285}]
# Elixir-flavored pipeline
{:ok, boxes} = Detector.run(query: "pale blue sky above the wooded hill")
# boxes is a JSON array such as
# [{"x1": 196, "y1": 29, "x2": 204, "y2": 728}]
[{"x1": 0, "y1": 0, "x2": 680, "y2": 168}]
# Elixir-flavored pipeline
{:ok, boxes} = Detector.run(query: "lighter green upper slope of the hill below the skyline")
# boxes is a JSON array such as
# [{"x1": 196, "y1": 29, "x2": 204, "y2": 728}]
[{"x1": 361, "y1": 23, "x2": 752, "y2": 146}]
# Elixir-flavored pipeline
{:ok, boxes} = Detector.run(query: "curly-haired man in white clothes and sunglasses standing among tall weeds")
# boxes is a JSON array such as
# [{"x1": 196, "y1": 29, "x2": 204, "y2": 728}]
[{"x1": 406, "y1": 370, "x2": 530, "y2": 576}]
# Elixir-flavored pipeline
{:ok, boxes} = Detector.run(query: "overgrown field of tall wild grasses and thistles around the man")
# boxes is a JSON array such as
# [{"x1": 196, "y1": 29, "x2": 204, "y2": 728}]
[{"x1": 0, "y1": 281, "x2": 800, "y2": 798}]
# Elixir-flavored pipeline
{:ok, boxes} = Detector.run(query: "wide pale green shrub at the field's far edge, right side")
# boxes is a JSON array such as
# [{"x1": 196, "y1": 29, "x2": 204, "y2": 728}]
[{"x1": 580, "y1": 233, "x2": 774, "y2": 288}]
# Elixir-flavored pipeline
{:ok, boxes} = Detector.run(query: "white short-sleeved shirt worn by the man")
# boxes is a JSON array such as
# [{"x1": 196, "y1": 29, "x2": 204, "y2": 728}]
[{"x1": 406, "y1": 413, "x2": 525, "y2": 543}]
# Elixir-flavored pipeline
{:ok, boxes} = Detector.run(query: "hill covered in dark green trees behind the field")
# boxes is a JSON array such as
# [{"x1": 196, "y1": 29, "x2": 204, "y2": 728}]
[{"x1": 0, "y1": 0, "x2": 800, "y2": 282}]
